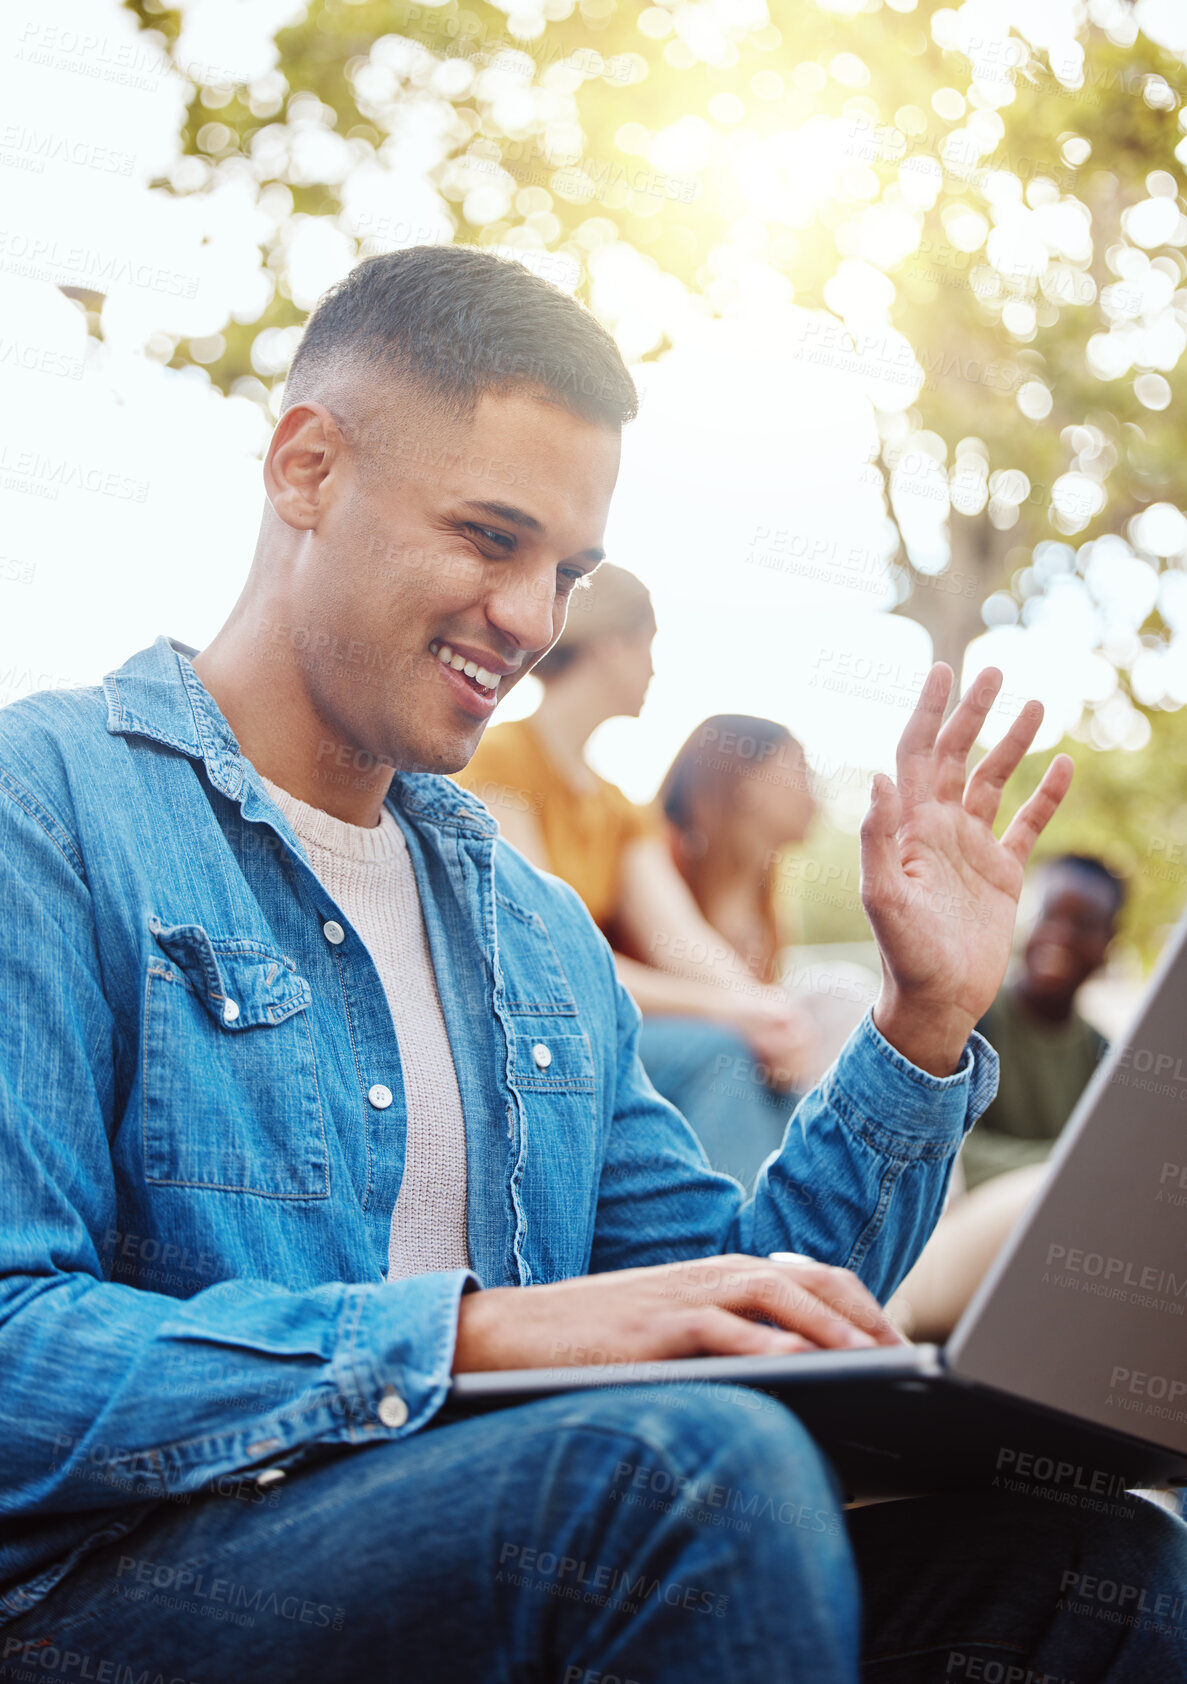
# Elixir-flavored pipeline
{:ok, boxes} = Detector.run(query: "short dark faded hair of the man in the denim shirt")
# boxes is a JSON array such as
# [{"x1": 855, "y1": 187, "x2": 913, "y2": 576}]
[{"x1": 283, "y1": 246, "x2": 638, "y2": 444}]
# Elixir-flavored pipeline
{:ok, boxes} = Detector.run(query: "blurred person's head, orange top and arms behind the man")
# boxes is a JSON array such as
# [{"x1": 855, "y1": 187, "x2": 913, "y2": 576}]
[{"x1": 456, "y1": 562, "x2": 815, "y2": 1151}]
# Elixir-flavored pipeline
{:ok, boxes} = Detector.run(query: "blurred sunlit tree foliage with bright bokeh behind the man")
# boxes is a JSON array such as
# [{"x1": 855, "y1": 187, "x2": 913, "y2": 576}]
[{"x1": 126, "y1": 0, "x2": 1187, "y2": 950}]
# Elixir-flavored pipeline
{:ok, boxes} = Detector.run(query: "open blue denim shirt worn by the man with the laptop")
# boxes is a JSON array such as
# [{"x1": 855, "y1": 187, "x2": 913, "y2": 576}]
[{"x1": 0, "y1": 637, "x2": 997, "y2": 1622}]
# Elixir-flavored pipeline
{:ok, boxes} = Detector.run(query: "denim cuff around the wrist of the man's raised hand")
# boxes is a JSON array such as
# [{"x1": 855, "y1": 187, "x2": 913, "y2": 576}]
[{"x1": 825, "y1": 1007, "x2": 997, "y2": 1157}]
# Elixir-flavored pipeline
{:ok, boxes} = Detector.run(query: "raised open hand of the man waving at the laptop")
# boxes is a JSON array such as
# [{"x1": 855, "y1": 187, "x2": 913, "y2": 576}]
[{"x1": 862, "y1": 662, "x2": 1073, "y2": 1076}]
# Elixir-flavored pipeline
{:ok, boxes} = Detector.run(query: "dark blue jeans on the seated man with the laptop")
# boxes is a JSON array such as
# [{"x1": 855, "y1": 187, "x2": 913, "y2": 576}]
[{"x1": 0, "y1": 1384, "x2": 1187, "y2": 1684}]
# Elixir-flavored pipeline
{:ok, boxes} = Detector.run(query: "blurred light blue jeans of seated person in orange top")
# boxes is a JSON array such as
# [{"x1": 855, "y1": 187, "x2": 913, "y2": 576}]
[{"x1": 638, "y1": 1017, "x2": 800, "y2": 1189}]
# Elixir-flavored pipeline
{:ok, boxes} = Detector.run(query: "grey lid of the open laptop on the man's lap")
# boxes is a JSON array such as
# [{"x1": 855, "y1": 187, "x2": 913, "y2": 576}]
[{"x1": 945, "y1": 914, "x2": 1187, "y2": 1452}]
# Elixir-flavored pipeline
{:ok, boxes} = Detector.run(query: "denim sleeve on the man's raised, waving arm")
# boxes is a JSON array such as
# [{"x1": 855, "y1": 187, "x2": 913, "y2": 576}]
[{"x1": 591, "y1": 963, "x2": 997, "y2": 1302}]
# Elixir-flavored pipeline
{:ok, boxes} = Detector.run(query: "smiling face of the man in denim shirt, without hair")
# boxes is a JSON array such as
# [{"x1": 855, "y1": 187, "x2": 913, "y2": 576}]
[{"x1": 269, "y1": 391, "x2": 620, "y2": 771}]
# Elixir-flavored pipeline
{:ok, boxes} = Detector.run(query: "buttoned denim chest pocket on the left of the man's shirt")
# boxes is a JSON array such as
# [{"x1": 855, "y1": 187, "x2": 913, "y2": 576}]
[{"x1": 141, "y1": 918, "x2": 330, "y2": 1199}]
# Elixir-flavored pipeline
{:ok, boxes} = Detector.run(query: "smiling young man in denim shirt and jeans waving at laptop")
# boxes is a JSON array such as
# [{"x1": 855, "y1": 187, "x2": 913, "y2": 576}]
[{"x1": 0, "y1": 240, "x2": 1187, "y2": 1684}]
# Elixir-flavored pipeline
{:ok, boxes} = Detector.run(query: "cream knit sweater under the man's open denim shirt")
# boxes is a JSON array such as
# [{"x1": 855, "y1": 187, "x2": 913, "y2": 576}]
[{"x1": 261, "y1": 773, "x2": 470, "y2": 1280}]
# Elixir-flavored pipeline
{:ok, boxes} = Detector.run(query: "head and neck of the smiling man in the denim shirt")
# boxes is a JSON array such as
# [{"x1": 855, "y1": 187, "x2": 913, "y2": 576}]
[{"x1": 194, "y1": 287, "x2": 619, "y2": 794}]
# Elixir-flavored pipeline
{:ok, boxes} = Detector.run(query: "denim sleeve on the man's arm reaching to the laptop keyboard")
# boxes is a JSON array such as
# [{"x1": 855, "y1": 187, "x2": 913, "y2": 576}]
[{"x1": 0, "y1": 768, "x2": 478, "y2": 1522}]
